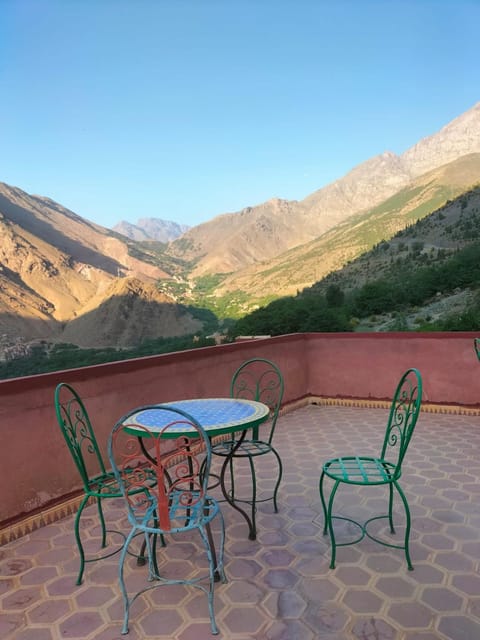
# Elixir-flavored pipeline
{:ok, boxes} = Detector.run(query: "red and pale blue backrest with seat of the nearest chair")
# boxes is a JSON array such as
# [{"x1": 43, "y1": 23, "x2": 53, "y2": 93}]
[{"x1": 108, "y1": 404, "x2": 212, "y2": 531}]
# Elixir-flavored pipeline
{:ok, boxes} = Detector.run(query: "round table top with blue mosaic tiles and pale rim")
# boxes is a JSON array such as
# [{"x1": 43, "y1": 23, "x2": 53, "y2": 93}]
[{"x1": 126, "y1": 398, "x2": 270, "y2": 438}]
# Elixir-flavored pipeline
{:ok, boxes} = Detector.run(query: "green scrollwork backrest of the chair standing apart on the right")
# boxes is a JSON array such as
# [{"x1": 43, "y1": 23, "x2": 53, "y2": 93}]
[{"x1": 380, "y1": 368, "x2": 422, "y2": 477}]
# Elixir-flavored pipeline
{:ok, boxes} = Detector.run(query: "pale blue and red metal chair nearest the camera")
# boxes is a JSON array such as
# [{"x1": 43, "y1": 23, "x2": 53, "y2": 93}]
[{"x1": 108, "y1": 405, "x2": 226, "y2": 634}]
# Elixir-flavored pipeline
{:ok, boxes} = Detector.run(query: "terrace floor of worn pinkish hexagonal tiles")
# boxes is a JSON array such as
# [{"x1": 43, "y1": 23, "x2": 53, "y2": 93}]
[{"x1": 0, "y1": 405, "x2": 480, "y2": 640}]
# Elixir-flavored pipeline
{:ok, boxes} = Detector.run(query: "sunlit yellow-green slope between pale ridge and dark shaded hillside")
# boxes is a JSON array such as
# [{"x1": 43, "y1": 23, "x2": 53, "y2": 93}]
[{"x1": 211, "y1": 153, "x2": 480, "y2": 308}]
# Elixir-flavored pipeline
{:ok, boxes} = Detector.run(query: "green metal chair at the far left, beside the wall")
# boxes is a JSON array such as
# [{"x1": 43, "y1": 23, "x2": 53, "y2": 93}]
[{"x1": 55, "y1": 382, "x2": 148, "y2": 585}]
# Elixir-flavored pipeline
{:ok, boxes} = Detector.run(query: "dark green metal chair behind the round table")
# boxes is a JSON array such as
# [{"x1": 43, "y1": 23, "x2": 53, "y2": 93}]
[{"x1": 212, "y1": 358, "x2": 284, "y2": 540}]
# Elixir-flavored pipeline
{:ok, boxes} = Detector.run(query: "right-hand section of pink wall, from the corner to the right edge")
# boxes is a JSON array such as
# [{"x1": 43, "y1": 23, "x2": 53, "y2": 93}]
[{"x1": 306, "y1": 332, "x2": 480, "y2": 405}]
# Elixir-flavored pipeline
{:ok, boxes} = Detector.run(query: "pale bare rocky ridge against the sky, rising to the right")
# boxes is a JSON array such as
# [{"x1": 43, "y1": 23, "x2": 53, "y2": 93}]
[{"x1": 167, "y1": 103, "x2": 480, "y2": 276}]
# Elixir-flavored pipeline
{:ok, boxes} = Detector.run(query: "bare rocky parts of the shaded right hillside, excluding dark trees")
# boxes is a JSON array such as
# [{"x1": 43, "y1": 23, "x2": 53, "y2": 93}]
[{"x1": 310, "y1": 185, "x2": 480, "y2": 331}]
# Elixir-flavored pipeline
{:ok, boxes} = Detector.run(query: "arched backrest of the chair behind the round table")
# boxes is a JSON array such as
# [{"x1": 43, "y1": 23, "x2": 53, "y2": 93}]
[{"x1": 230, "y1": 358, "x2": 284, "y2": 444}]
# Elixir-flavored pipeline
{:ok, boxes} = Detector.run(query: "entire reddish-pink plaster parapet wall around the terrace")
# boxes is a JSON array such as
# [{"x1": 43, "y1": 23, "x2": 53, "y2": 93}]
[{"x1": 0, "y1": 333, "x2": 480, "y2": 526}]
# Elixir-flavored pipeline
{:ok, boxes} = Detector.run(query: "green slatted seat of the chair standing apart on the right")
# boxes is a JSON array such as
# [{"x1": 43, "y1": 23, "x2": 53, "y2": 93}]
[{"x1": 323, "y1": 456, "x2": 400, "y2": 485}]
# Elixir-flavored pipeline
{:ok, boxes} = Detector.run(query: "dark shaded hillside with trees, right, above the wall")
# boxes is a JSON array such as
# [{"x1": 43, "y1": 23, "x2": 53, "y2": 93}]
[{"x1": 233, "y1": 185, "x2": 480, "y2": 335}]
